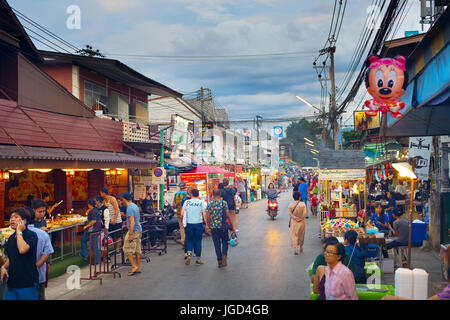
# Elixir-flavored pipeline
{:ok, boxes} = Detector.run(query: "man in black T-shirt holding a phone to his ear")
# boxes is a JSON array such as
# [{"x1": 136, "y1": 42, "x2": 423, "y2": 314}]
[{"x1": 0, "y1": 208, "x2": 39, "y2": 300}]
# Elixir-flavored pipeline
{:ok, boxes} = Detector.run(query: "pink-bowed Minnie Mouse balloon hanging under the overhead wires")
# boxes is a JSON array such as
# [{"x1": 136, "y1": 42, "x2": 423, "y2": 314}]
[{"x1": 364, "y1": 55, "x2": 408, "y2": 118}]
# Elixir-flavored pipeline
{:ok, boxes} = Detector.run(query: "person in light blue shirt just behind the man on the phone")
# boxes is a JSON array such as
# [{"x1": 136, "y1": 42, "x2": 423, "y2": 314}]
[{"x1": 28, "y1": 210, "x2": 54, "y2": 300}]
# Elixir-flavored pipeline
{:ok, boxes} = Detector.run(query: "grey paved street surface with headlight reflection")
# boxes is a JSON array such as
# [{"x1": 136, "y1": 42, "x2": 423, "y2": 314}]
[{"x1": 50, "y1": 191, "x2": 320, "y2": 300}]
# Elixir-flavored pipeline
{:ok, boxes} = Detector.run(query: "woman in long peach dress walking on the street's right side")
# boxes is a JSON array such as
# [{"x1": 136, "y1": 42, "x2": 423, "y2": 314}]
[{"x1": 288, "y1": 191, "x2": 306, "y2": 255}]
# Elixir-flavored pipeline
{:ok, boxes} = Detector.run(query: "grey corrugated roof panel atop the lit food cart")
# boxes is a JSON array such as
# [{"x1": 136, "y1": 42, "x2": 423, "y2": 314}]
[{"x1": 319, "y1": 149, "x2": 366, "y2": 169}]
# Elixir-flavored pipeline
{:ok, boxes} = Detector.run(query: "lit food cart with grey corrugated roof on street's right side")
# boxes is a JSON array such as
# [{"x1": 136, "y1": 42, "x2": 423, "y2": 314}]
[{"x1": 319, "y1": 150, "x2": 366, "y2": 238}]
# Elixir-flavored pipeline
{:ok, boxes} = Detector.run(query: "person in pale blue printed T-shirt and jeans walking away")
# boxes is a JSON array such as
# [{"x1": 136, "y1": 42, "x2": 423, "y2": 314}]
[{"x1": 181, "y1": 189, "x2": 208, "y2": 265}]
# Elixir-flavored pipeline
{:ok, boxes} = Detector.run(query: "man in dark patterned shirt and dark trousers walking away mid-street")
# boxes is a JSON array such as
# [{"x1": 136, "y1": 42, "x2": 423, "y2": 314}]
[{"x1": 206, "y1": 189, "x2": 236, "y2": 268}]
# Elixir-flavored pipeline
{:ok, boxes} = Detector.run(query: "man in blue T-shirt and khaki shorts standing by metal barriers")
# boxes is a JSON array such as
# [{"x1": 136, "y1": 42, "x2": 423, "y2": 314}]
[{"x1": 120, "y1": 192, "x2": 142, "y2": 276}]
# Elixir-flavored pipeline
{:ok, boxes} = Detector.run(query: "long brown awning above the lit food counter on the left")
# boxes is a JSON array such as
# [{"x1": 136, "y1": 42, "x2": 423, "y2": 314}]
[{"x1": 0, "y1": 145, "x2": 157, "y2": 169}]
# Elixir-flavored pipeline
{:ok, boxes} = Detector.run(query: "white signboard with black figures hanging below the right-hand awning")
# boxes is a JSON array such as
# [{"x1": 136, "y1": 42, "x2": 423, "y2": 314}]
[{"x1": 408, "y1": 137, "x2": 433, "y2": 180}]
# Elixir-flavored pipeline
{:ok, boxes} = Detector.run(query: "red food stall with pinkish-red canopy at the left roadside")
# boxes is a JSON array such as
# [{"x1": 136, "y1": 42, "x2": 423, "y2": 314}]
[{"x1": 180, "y1": 165, "x2": 235, "y2": 201}]
